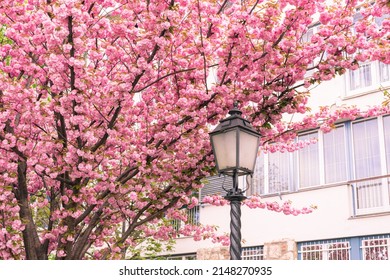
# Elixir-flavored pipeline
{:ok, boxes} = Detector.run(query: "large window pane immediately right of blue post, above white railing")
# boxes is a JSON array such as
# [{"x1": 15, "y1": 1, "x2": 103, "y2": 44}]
[{"x1": 352, "y1": 119, "x2": 381, "y2": 179}]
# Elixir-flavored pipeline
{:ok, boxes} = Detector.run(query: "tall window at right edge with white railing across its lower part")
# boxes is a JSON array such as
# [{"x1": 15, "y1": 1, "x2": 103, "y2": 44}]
[{"x1": 352, "y1": 116, "x2": 390, "y2": 215}]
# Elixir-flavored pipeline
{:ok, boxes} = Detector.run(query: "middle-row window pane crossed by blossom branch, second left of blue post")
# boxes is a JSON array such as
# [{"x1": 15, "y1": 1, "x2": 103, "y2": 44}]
[{"x1": 298, "y1": 132, "x2": 320, "y2": 188}]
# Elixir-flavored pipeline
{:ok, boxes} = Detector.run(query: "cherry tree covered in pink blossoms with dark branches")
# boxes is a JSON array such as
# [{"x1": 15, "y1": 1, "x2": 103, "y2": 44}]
[{"x1": 0, "y1": 0, "x2": 390, "y2": 259}]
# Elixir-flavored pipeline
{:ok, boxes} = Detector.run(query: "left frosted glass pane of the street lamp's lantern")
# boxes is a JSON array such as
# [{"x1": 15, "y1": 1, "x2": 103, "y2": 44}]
[{"x1": 211, "y1": 130, "x2": 237, "y2": 169}]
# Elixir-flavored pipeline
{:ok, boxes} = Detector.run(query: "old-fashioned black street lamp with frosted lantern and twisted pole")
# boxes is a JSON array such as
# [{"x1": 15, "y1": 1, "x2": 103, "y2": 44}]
[{"x1": 210, "y1": 103, "x2": 260, "y2": 260}]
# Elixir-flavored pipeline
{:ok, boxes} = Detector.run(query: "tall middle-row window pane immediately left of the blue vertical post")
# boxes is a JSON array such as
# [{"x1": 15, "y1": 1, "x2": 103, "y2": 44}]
[{"x1": 324, "y1": 126, "x2": 347, "y2": 183}]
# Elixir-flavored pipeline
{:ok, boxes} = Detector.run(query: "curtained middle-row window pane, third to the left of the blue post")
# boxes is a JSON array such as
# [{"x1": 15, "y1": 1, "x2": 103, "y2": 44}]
[{"x1": 268, "y1": 152, "x2": 290, "y2": 193}]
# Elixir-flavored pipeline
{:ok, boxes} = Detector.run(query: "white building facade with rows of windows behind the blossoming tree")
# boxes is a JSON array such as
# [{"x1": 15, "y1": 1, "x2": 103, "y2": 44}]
[{"x1": 166, "y1": 58, "x2": 390, "y2": 260}]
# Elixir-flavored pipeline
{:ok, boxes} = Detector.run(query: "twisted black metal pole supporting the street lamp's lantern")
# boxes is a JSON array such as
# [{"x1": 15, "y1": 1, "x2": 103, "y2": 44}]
[{"x1": 225, "y1": 172, "x2": 246, "y2": 260}]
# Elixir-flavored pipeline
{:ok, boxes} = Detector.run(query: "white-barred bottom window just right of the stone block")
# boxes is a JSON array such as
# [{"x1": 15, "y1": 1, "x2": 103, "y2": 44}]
[{"x1": 298, "y1": 240, "x2": 351, "y2": 260}]
